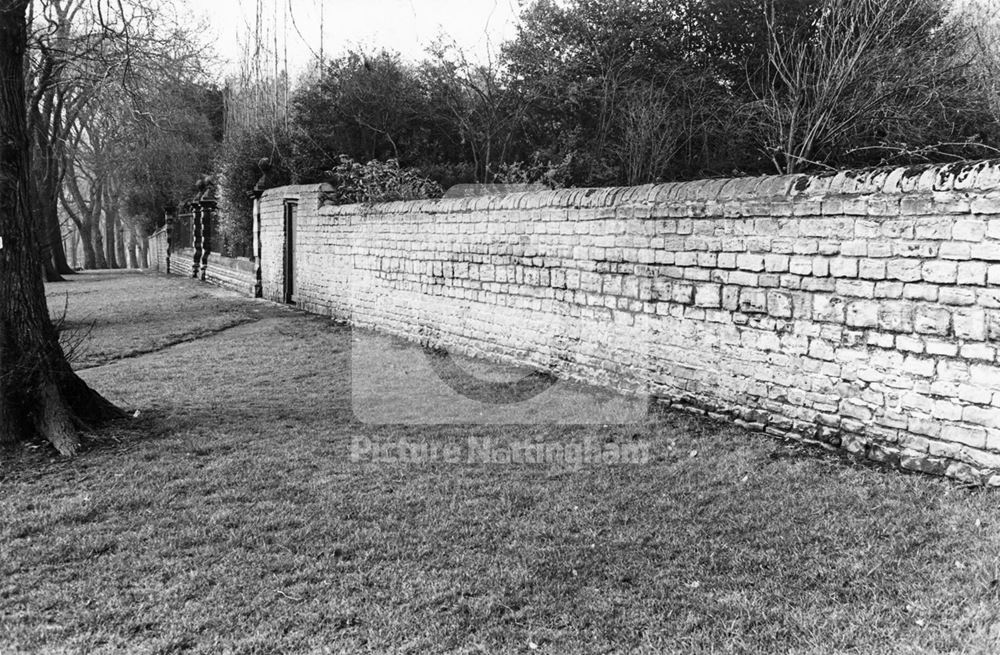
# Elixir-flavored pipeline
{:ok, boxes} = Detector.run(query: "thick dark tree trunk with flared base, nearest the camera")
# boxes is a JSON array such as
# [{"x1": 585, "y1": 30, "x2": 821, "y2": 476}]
[{"x1": 0, "y1": 0, "x2": 122, "y2": 455}]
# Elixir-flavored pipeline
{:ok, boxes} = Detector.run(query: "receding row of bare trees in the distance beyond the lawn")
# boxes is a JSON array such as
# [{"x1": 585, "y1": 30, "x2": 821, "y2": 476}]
[{"x1": 24, "y1": 0, "x2": 222, "y2": 281}]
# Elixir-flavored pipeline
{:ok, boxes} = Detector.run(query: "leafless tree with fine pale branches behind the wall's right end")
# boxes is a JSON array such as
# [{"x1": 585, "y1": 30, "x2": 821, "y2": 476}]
[{"x1": 754, "y1": 0, "x2": 984, "y2": 173}]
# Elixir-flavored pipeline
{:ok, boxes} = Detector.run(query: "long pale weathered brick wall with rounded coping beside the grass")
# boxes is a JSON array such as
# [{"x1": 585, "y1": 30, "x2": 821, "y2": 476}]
[{"x1": 261, "y1": 162, "x2": 1000, "y2": 484}]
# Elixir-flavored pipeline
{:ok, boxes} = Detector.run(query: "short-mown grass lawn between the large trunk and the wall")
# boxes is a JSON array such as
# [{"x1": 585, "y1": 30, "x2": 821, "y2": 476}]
[{"x1": 0, "y1": 273, "x2": 1000, "y2": 654}]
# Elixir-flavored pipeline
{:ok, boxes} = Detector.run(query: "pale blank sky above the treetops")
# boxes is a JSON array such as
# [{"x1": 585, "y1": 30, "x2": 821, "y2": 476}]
[{"x1": 192, "y1": 0, "x2": 519, "y2": 73}]
